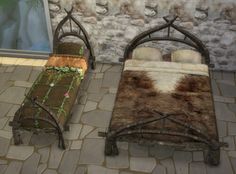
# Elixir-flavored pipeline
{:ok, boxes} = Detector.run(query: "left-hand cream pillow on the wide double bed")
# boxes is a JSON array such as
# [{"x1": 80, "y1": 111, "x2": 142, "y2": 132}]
[{"x1": 132, "y1": 47, "x2": 162, "y2": 61}]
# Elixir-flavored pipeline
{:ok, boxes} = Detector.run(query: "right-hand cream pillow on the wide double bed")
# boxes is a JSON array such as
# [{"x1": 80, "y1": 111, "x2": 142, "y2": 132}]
[{"x1": 171, "y1": 50, "x2": 202, "y2": 64}]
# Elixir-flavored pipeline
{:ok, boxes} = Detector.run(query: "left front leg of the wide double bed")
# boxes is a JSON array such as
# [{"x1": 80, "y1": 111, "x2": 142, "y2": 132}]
[{"x1": 105, "y1": 138, "x2": 119, "y2": 156}]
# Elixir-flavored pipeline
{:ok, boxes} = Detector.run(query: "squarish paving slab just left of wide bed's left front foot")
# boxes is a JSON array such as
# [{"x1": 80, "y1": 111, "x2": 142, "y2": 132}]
[{"x1": 79, "y1": 139, "x2": 105, "y2": 165}]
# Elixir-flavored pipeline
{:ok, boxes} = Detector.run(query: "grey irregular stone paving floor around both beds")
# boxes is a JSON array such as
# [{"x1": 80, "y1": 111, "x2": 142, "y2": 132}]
[{"x1": 0, "y1": 58, "x2": 236, "y2": 174}]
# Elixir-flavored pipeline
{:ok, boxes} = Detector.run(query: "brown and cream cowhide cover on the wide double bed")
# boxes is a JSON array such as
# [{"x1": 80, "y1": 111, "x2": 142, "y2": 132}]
[{"x1": 110, "y1": 60, "x2": 217, "y2": 142}]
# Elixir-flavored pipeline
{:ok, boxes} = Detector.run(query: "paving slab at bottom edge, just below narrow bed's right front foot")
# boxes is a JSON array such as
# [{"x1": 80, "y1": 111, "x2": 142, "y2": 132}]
[{"x1": 58, "y1": 150, "x2": 80, "y2": 174}]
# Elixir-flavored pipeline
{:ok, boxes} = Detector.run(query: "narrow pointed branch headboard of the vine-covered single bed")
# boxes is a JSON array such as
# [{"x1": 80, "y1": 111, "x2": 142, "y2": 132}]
[{"x1": 53, "y1": 8, "x2": 95, "y2": 69}]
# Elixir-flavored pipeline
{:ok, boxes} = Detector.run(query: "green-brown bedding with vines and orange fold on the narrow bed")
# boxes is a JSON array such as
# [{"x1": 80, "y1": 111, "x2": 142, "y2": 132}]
[{"x1": 12, "y1": 55, "x2": 87, "y2": 131}]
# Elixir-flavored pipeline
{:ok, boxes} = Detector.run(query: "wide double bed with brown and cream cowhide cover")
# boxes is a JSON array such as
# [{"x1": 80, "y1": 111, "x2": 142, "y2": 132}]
[{"x1": 99, "y1": 17, "x2": 226, "y2": 165}]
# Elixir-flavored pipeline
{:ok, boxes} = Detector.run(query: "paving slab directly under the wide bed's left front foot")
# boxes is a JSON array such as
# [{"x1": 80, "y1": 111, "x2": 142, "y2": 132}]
[{"x1": 106, "y1": 150, "x2": 129, "y2": 169}]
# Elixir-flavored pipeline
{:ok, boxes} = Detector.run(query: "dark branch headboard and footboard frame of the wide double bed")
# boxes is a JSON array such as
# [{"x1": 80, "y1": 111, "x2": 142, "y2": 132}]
[{"x1": 99, "y1": 17, "x2": 227, "y2": 165}]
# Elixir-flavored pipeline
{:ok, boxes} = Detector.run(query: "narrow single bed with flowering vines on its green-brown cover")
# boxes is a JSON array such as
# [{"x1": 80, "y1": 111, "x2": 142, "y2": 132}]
[{"x1": 10, "y1": 10, "x2": 95, "y2": 149}]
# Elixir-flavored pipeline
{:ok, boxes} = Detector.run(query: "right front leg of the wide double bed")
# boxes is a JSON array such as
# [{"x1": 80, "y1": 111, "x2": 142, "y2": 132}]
[{"x1": 204, "y1": 147, "x2": 220, "y2": 166}]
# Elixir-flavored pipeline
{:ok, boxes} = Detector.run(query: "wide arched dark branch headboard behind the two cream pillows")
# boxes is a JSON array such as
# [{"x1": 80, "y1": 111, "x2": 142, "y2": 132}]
[{"x1": 123, "y1": 16, "x2": 212, "y2": 67}]
